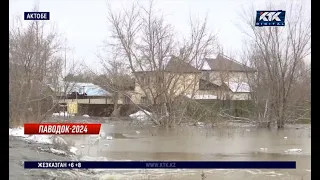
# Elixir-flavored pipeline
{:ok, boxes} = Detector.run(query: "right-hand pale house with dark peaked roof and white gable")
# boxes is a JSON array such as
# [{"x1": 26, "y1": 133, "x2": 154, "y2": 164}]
[{"x1": 198, "y1": 54, "x2": 256, "y2": 100}]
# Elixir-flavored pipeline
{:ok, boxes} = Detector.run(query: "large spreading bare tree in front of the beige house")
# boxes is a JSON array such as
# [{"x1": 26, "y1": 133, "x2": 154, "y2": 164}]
[{"x1": 108, "y1": 1, "x2": 215, "y2": 126}]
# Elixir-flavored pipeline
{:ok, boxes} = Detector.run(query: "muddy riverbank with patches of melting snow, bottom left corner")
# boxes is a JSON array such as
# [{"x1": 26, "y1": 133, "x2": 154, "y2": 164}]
[{"x1": 9, "y1": 131, "x2": 104, "y2": 180}]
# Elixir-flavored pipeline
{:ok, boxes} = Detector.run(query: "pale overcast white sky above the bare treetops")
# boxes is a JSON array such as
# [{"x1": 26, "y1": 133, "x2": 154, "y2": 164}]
[{"x1": 9, "y1": 0, "x2": 311, "y2": 73}]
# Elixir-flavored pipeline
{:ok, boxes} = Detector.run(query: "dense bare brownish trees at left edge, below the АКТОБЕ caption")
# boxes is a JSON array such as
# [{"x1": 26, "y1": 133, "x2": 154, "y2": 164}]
[{"x1": 9, "y1": 10, "x2": 63, "y2": 124}]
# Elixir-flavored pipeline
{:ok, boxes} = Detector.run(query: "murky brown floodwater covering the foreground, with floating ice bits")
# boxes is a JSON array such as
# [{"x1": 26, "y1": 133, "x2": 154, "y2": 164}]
[{"x1": 62, "y1": 121, "x2": 311, "y2": 180}]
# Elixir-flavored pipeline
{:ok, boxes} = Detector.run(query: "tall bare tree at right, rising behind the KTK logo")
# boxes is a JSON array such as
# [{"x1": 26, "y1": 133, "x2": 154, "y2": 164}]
[{"x1": 240, "y1": 5, "x2": 311, "y2": 128}]
